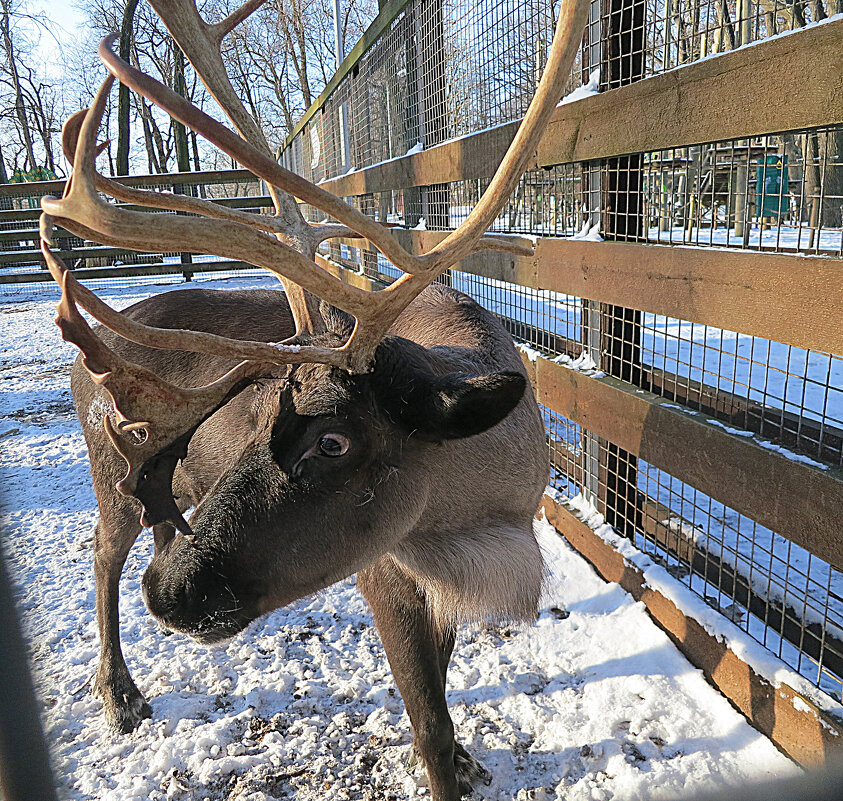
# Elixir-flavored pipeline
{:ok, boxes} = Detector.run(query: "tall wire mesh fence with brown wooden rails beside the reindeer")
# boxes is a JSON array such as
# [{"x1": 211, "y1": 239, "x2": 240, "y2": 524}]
[{"x1": 282, "y1": 0, "x2": 843, "y2": 763}]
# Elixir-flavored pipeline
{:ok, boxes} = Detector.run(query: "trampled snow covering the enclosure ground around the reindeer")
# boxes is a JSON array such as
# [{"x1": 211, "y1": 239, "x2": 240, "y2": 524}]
[{"x1": 0, "y1": 278, "x2": 797, "y2": 801}]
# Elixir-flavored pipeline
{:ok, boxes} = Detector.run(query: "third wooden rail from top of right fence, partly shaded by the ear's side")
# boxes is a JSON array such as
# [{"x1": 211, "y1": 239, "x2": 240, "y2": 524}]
[{"x1": 535, "y1": 357, "x2": 843, "y2": 570}]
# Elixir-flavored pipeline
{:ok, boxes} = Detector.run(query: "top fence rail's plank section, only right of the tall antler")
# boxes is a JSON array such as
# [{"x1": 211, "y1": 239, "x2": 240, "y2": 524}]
[{"x1": 537, "y1": 19, "x2": 843, "y2": 166}]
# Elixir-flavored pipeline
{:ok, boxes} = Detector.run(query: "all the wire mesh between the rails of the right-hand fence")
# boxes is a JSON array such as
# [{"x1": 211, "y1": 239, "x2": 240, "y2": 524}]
[{"x1": 285, "y1": 0, "x2": 843, "y2": 699}]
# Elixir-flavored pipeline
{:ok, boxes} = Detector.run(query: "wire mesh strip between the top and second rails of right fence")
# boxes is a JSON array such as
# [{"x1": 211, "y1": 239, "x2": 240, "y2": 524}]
[{"x1": 372, "y1": 126, "x2": 843, "y2": 256}]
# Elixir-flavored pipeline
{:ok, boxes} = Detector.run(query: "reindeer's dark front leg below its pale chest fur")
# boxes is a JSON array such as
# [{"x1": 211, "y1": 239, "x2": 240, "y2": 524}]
[{"x1": 357, "y1": 557, "x2": 488, "y2": 801}]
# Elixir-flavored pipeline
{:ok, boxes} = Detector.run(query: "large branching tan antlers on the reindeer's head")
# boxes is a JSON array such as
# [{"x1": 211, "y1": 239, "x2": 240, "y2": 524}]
[{"x1": 41, "y1": 0, "x2": 588, "y2": 531}]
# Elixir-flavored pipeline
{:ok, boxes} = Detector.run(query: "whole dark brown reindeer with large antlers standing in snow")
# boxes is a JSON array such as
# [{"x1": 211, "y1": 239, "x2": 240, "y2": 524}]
[{"x1": 41, "y1": 0, "x2": 587, "y2": 801}]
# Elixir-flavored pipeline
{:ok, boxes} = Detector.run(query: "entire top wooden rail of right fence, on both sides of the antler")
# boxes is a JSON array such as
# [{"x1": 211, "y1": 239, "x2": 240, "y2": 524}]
[{"x1": 322, "y1": 19, "x2": 843, "y2": 197}]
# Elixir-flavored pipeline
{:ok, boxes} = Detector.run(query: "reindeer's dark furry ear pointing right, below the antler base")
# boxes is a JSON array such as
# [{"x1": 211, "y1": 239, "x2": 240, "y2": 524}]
[{"x1": 402, "y1": 372, "x2": 527, "y2": 442}]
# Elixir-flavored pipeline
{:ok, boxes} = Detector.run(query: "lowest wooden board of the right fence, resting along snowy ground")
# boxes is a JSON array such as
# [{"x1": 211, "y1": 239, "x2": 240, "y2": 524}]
[{"x1": 542, "y1": 496, "x2": 843, "y2": 766}]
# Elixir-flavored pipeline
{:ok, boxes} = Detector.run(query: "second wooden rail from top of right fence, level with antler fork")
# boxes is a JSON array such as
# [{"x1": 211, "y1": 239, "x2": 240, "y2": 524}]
[{"x1": 380, "y1": 229, "x2": 843, "y2": 353}]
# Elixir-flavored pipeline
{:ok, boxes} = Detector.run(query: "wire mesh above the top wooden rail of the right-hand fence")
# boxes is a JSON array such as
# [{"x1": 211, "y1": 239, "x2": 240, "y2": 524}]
[{"x1": 286, "y1": 0, "x2": 834, "y2": 181}]
